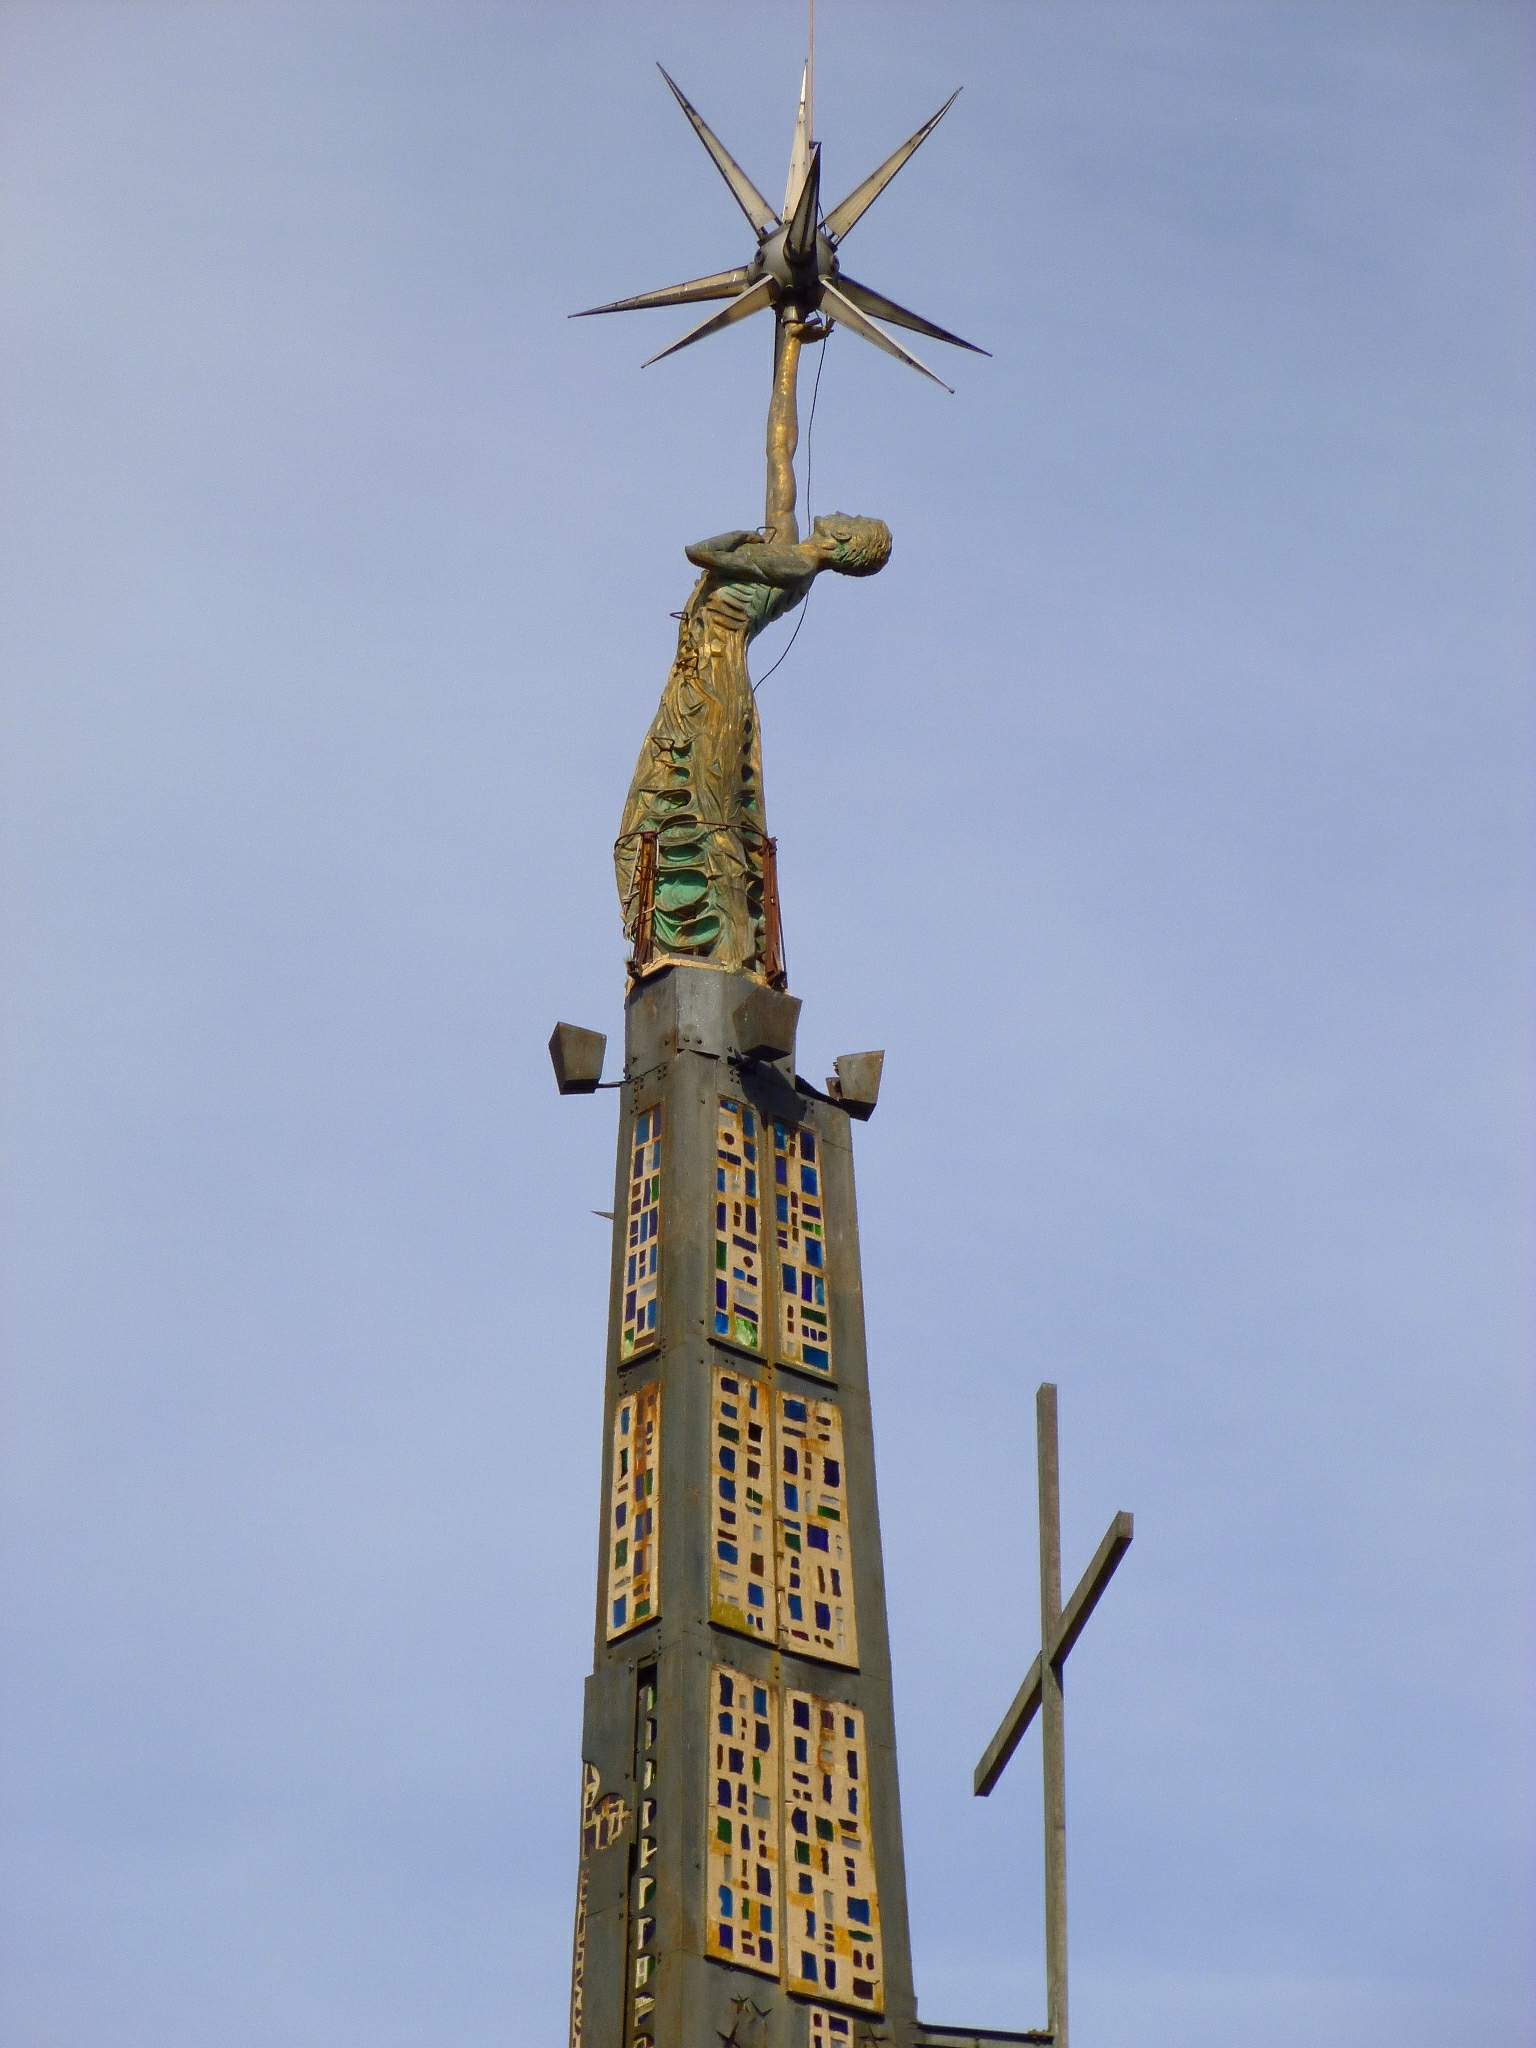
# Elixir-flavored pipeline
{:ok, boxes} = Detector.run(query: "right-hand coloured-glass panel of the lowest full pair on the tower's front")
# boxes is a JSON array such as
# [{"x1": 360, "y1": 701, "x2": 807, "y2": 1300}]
[{"x1": 784, "y1": 1692, "x2": 885, "y2": 2013}]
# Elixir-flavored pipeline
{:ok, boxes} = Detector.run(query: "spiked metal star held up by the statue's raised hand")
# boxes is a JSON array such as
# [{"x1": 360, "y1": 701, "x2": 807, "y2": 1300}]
[{"x1": 571, "y1": 63, "x2": 989, "y2": 391}]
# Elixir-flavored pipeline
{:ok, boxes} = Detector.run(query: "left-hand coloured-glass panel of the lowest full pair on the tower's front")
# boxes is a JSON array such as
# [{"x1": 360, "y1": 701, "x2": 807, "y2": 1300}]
[{"x1": 705, "y1": 1665, "x2": 780, "y2": 1976}]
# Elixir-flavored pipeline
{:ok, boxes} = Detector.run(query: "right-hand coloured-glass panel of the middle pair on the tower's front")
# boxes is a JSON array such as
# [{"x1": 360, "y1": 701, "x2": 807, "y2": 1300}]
[{"x1": 774, "y1": 1393, "x2": 858, "y2": 1667}]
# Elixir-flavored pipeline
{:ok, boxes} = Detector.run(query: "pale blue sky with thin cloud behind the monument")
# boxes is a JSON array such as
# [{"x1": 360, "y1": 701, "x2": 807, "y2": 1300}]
[{"x1": 0, "y1": 0, "x2": 1536, "y2": 2048}]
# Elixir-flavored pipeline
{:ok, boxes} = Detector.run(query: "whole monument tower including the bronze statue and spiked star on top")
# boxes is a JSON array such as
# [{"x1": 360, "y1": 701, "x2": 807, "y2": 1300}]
[{"x1": 551, "y1": 36, "x2": 1130, "y2": 2048}]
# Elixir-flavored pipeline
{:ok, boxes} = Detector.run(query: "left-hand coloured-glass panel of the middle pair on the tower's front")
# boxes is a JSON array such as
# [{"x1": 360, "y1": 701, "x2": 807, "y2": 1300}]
[{"x1": 709, "y1": 1366, "x2": 778, "y2": 1642}]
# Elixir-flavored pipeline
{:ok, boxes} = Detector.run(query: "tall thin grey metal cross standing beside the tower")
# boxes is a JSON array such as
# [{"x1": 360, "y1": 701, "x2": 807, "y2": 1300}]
[{"x1": 975, "y1": 1380, "x2": 1135, "y2": 2048}]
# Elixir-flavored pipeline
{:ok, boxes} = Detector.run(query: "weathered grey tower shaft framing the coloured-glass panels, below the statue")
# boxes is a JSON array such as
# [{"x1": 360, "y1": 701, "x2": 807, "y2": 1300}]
[{"x1": 571, "y1": 967, "x2": 921, "y2": 2048}]
